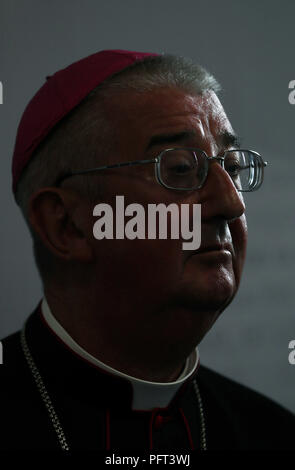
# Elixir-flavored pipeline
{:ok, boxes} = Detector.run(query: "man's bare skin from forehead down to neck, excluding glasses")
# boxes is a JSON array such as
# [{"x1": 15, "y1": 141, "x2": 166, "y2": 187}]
[{"x1": 31, "y1": 88, "x2": 247, "y2": 381}]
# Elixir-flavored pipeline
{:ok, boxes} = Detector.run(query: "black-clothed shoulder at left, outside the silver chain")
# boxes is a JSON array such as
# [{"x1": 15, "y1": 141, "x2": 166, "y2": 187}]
[{"x1": 0, "y1": 332, "x2": 55, "y2": 451}]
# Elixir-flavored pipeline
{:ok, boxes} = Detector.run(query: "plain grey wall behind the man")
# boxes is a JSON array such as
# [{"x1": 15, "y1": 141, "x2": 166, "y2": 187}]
[{"x1": 0, "y1": 0, "x2": 295, "y2": 411}]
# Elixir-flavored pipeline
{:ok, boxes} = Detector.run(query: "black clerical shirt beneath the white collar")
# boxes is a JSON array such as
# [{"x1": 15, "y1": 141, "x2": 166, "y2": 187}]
[{"x1": 0, "y1": 307, "x2": 295, "y2": 452}]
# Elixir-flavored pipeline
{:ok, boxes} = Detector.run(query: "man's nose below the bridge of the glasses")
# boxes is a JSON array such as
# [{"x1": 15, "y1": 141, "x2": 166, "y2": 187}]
[{"x1": 198, "y1": 161, "x2": 245, "y2": 221}]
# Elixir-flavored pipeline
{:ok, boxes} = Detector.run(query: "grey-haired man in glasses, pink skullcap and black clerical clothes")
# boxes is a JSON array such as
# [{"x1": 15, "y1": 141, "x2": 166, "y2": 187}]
[{"x1": 0, "y1": 50, "x2": 294, "y2": 451}]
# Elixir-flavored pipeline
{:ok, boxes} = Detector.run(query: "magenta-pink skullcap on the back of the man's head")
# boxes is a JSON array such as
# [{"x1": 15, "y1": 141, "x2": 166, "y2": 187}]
[{"x1": 12, "y1": 50, "x2": 158, "y2": 192}]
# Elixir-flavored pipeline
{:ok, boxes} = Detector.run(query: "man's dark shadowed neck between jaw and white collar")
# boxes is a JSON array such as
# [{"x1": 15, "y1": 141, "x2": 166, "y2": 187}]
[{"x1": 45, "y1": 282, "x2": 205, "y2": 382}]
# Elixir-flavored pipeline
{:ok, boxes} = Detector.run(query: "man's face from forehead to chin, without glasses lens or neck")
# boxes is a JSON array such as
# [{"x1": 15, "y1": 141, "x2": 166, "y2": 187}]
[{"x1": 85, "y1": 88, "x2": 247, "y2": 348}]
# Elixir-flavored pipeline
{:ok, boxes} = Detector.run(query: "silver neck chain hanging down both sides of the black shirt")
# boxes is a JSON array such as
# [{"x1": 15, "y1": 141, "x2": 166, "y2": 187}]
[{"x1": 20, "y1": 323, "x2": 207, "y2": 451}]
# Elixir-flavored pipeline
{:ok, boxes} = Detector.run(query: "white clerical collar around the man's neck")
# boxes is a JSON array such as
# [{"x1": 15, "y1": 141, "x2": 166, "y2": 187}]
[{"x1": 41, "y1": 297, "x2": 199, "y2": 410}]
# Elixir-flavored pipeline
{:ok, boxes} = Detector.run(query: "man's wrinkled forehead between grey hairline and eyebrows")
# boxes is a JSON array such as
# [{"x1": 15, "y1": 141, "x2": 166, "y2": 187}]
[{"x1": 106, "y1": 88, "x2": 233, "y2": 151}]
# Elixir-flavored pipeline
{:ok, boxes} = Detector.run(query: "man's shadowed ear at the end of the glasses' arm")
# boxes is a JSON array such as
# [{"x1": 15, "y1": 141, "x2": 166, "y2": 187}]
[{"x1": 29, "y1": 188, "x2": 93, "y2": 262}]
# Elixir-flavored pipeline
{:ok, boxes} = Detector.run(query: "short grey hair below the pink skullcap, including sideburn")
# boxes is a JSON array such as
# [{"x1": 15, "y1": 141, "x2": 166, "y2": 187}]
[{"x1": 15, "y1": 54, "x2": 220, "y2": 277}]
